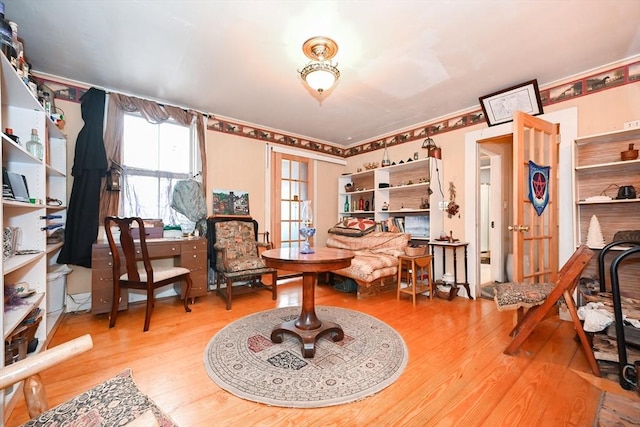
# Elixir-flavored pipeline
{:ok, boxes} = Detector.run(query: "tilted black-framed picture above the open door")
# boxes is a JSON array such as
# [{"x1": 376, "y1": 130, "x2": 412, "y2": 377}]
[{"x1": 480, "y1": 80, "x2": 542, "y2": 126}]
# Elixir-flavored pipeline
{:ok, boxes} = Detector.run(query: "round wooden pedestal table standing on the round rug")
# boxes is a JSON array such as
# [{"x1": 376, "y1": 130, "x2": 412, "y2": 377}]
[{"x1": 262, "y1": 248, "x2": 354, "y2": 357}]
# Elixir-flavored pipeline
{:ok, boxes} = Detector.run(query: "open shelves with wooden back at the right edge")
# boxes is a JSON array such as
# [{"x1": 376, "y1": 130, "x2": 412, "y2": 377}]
[{"x1": 573, "y1": 129, "x2": 640, "y2": 298}]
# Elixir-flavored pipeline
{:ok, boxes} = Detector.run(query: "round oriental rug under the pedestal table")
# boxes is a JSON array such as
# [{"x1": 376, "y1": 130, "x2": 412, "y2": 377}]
[{"x1": 204, "y1": 306, "x2": 409, "y2": 408}]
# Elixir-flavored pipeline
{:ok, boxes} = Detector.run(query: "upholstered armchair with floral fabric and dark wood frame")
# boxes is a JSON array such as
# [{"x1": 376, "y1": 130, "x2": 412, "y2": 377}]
[{"x1": 207, "y1": 218, "x2": 278, "y2": 310}]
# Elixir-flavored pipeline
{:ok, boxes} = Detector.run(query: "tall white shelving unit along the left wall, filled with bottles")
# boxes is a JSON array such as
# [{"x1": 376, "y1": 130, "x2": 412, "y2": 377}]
[{"x1": 0, "y1": 51, "x2": 67, "y2": 420}]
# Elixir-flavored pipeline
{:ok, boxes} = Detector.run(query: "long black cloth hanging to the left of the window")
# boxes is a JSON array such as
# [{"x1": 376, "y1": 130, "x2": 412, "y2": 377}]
[{"x1": 57, "y1": 88, "x2": 108, "y2": 268}]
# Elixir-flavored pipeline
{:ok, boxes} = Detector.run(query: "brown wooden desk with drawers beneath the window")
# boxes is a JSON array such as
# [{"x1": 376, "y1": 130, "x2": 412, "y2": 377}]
[{"x1": 91, "y1": 237, "x2": 207, "y2": 314}]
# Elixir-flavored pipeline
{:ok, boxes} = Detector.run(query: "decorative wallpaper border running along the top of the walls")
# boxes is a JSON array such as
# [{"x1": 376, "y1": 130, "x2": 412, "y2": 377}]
[{"x1": 36, "y1": 61, "x2": 640, "y2": 158}]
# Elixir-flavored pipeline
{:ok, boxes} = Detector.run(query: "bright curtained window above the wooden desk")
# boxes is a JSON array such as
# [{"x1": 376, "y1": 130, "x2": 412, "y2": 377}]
[{"x1": 120, "y1": 114, "x2": 198, "y2": 224}]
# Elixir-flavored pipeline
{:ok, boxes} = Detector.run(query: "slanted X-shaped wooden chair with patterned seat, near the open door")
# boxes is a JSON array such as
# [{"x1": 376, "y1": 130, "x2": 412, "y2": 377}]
[{"x1": 494, "y1": 245, "x2": 600, "y2": 376}]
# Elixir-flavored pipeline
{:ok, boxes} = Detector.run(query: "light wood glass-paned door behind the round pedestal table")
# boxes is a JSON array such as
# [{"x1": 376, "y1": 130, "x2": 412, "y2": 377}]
[{"x1": 271, "y1": 152, "x2": 314, "y2": 248}]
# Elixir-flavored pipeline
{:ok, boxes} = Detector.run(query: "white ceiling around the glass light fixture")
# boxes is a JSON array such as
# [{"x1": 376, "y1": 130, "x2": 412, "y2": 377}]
[{"x1": 4, "y1": 0, "x2": 640, "y2": 146}]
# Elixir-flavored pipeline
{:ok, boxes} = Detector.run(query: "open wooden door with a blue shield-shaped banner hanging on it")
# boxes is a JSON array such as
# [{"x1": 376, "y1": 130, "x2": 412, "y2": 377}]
[{"x1": 508, "y1": 111, "x2": 570, "y2": 283}]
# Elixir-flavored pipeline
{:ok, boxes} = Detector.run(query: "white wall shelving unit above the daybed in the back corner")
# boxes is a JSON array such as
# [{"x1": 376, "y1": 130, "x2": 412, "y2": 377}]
[{"x1": 338, "y1": 158, "x2": 443, "y2": 243}]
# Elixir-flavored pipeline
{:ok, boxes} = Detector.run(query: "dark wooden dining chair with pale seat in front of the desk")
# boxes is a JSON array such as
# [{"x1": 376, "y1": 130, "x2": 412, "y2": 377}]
[{"x1": 104, "y1": 216, "x2": 192, "y2": 332}]
